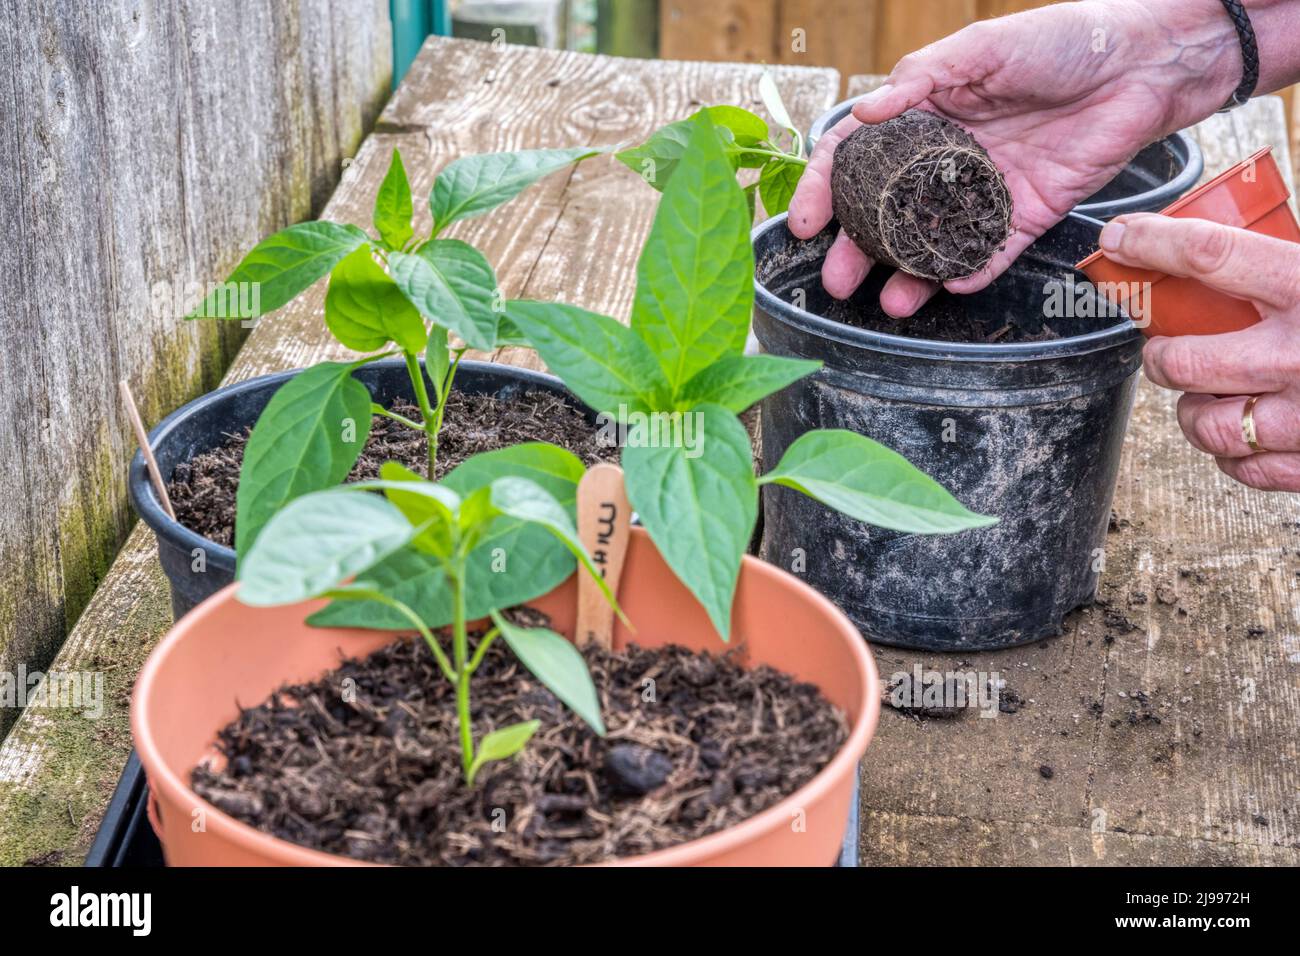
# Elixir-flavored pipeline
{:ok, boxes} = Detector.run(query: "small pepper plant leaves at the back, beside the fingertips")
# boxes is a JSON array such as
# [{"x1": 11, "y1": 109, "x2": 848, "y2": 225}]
[{"x1": 615, "y1": 70, "x2": 807, "y2": 216}]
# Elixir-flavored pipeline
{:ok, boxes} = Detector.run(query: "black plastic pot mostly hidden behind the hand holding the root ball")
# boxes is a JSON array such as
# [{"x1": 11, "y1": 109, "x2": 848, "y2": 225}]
[{"x1": 803, "y1": 98, "x2": 1205, "y2": 220}]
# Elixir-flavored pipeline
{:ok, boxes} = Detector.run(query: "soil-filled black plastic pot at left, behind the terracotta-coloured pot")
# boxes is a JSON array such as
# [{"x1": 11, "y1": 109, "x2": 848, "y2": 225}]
[{"x1": 129, "y1": 359, "x2": 605, "y2": 619}]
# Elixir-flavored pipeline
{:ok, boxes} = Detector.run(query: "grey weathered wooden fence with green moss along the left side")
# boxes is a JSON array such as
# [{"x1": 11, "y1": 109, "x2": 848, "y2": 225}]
[{"x1": 0, "y1": 0, "x2": 390, "y2": 734}]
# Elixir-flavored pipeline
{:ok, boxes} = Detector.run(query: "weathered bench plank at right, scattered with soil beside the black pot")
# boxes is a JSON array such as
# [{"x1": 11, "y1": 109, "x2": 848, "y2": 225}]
[{"x1": 850, "y1": 91, "x2": 1300, "y2": 865}]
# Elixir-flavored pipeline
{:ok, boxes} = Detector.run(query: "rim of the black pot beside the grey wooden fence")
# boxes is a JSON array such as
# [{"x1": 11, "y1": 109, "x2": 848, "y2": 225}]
[{"x1": 126, "y1": 356, "x2": 572, "y2": 566}]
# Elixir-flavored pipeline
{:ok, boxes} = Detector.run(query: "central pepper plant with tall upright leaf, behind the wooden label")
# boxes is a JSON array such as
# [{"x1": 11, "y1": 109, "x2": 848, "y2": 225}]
[{"x1": 506, "y1": 109, "x2": 997, "y2": 640}]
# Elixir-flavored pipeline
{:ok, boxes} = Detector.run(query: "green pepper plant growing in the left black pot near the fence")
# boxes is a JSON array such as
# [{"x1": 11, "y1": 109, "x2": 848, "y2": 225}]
[{"x1": 187, "y1": 147, "x2": 598, "y2": 558}]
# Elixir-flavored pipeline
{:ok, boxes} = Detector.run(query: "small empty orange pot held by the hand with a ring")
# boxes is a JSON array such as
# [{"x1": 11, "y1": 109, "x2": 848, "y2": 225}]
[{"x1": 1076, "y1": 146, "x2": 1300, "y2": 336}]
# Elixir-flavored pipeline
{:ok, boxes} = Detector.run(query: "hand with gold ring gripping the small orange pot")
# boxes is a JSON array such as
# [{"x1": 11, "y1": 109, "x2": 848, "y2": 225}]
[{"x1": 1101, "y1": 213, "x2": 1300, "y2": 492}]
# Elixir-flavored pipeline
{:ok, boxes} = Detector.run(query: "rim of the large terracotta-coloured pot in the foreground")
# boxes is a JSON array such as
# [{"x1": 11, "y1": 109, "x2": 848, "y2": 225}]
[{"x1": 131, "y1": 528, "x2": 881, "y2": 866}]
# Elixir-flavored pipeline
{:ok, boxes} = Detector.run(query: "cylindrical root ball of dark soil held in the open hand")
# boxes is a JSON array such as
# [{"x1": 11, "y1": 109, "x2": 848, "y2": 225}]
[{"x1": 831, "y1": 109, "x2": 1011, "y2": 280}]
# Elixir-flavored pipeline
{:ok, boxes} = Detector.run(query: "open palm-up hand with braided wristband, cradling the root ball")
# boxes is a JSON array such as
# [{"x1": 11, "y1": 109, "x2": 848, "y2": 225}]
[{"x1": 789, "y1": 0, "x2": 1240, "y2": 316}]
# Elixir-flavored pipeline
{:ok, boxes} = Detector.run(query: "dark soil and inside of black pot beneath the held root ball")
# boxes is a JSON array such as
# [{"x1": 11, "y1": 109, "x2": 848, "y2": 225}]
[{"x1": 757, "y1": 230, "x2": 1071, "y2": 343}]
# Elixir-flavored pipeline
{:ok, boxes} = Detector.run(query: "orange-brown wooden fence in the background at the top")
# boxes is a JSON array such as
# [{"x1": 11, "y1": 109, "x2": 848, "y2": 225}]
[{"x1": 659, "y1": 0, "x2": 1300, "y2": 163}]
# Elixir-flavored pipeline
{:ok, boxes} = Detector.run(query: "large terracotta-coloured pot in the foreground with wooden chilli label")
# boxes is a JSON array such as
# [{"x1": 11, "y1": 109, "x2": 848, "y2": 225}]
[{"x1": 131, "y1": 528, "x2": 880, "y2": 866}]
